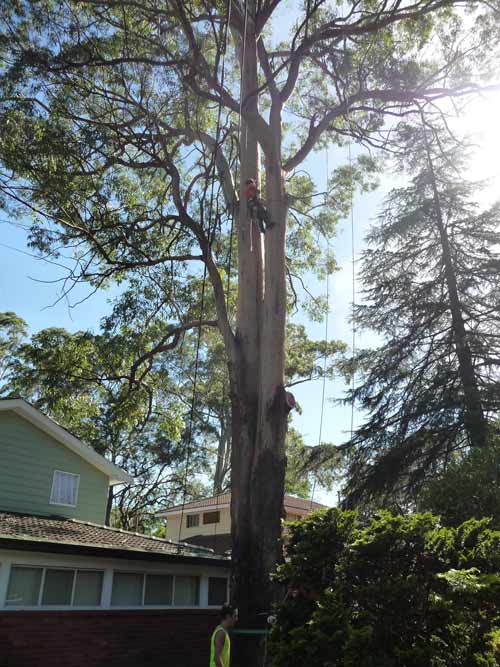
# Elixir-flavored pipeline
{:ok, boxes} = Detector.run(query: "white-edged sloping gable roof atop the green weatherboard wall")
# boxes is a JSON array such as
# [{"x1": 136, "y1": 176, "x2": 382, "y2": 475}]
[{"x1": 0, "y1": 398, "x2": 134, "y2": 485}]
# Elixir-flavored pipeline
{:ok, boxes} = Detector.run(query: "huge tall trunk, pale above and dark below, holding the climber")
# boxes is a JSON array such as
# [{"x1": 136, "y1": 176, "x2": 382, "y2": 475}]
[{"x1": 231, "y1": 1, "x2": 287, "y2": 667}]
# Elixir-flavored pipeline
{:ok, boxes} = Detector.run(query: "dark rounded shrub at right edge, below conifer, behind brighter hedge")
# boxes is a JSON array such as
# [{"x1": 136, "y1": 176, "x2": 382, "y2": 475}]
[{"x1": 419, "y1": 437, "x2": 500, "y2": 529}]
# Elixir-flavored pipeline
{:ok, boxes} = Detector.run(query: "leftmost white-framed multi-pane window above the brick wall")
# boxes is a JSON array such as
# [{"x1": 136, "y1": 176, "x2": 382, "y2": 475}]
[{"x1": 5, "y1": 566, "x2": 104, "y2": 607}]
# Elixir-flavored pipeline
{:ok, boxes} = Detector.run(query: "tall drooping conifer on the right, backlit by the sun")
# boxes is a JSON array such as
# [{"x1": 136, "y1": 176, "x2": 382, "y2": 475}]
[{"x1": 345, "y1": 116, "x2": 500, "y2": 505}]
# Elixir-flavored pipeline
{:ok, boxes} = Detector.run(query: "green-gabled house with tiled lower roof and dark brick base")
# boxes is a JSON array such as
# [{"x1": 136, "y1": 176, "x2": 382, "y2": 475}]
[{"x1": 0, "y1": 399, "x2": 229, "y2": 667}]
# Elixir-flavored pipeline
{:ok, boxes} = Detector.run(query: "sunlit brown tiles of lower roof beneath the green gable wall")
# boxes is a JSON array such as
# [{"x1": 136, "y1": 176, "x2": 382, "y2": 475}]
[{"x1": 0, "y1": 512, "x2": 227, "y2": 560}]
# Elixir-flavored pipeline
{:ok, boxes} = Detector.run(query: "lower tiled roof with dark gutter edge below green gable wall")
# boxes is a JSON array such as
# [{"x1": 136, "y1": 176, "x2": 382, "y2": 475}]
[{"x1": 0, "y1": 512, "x2": 227, "y2": 565}]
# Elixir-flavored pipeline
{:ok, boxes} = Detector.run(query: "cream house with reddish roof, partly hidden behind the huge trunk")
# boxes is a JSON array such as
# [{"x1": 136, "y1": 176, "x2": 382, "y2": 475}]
[{"x1": 156, "y1": 493, "x2": 326, "y2": 553}]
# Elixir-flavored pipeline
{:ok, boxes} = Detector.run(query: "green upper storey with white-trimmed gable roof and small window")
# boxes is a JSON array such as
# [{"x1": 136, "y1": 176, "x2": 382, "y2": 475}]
[{"x1": 0, "y1": 399, "x2": 132, "y2": 524}]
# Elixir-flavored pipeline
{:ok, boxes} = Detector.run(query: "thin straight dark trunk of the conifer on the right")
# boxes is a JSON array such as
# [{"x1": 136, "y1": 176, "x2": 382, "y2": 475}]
[{"x1": 421, "y1": 112, "x2": 486, "y2": 447}]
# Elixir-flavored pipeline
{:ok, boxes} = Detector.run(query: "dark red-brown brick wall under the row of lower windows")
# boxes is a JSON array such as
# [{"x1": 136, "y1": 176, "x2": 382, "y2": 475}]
[{"x1": 0, "y1": 610, "x2": 218, "y2": 667}]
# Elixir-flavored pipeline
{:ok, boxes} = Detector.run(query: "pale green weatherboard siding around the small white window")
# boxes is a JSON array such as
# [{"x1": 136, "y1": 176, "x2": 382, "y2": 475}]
[{"x1": 0, "y1": 412, "x2": 109, "y2": 524}]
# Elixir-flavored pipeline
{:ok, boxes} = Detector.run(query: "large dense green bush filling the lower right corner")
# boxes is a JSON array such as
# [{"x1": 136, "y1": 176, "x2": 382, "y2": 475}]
[{"x1": 269, "y1": 509, "x2": 500, "y2": 667}]
